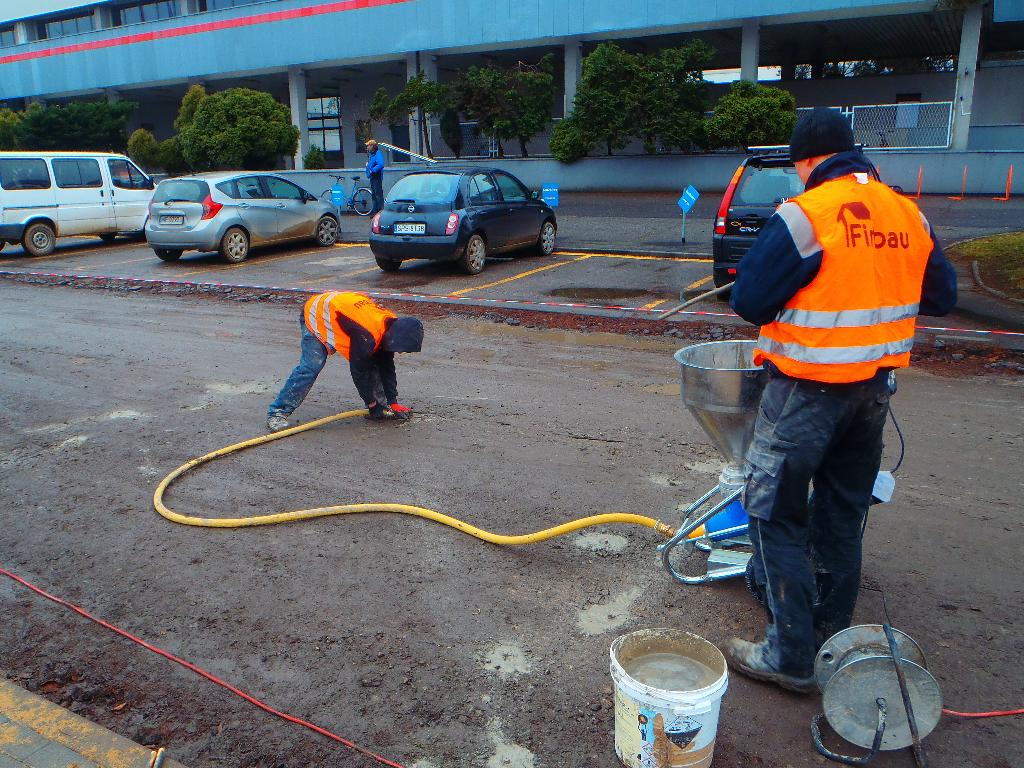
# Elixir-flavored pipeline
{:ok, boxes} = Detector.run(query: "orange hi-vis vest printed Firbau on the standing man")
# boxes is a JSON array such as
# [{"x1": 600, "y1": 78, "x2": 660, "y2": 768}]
[{"x1": 754, "y1": 173, "x2": 932, "y2": 383}]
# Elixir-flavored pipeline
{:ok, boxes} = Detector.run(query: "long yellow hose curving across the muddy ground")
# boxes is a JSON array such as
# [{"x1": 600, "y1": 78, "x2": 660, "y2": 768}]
[{"x1": 153, "y1": 410, "x2": 675, "y2": 546}]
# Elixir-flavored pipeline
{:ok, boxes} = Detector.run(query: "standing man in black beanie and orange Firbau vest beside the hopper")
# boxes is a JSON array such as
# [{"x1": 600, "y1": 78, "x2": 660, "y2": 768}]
[{"x1": 725, "y1": 108, "x2": 956, "y2": 692}]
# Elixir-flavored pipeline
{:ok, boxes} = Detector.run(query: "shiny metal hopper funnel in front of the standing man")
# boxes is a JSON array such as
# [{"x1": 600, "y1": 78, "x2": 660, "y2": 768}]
[{"x1": 675, "y1": 341, "x2": 768, "y2": 486}]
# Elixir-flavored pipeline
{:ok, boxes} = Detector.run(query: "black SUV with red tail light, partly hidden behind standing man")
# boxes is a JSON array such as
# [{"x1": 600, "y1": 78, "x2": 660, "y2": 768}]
[{"x1": 712, "y1": 145, "x2": 880, "y2": 287}]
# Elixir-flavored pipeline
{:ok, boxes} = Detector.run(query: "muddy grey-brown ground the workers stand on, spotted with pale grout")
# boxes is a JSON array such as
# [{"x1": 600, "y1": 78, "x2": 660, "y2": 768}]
[{"x1": 0, "y1": 284, "x2": 1024, "y2": 768}]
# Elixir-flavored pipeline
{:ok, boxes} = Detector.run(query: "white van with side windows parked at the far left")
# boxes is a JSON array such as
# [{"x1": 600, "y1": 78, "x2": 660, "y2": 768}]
[{"x1": 0, "y1": 152, "x2": 156, "y2": 256}]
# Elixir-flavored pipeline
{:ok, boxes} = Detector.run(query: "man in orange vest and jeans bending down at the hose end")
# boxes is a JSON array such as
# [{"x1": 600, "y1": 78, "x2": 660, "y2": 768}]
[{"x1": 266, "y1": 291, "x2": 423, "y2": 432}]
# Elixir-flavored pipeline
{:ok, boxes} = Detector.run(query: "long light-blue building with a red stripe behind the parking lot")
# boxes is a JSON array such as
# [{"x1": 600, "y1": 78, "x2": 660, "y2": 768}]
[{"x1": 0, "y1": 0, "x2": 1024, "y2": 165}]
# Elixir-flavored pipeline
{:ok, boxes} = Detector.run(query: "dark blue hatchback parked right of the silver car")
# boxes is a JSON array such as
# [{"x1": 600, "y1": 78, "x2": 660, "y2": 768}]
[{"x1": 370, "y1": 168, "x2": 557, "y2": 274}]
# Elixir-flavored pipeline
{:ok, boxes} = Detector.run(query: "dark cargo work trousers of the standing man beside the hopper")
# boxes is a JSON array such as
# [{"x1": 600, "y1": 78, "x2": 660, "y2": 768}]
[{"x1": 743, "y1": 374, "x2": 889, "y2": 677}]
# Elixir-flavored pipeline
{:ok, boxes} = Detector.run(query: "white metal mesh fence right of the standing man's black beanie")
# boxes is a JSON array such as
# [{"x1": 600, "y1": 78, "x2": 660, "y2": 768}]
[{"x1": 797, "y1": 101, "x2": 953, "y2": 150}]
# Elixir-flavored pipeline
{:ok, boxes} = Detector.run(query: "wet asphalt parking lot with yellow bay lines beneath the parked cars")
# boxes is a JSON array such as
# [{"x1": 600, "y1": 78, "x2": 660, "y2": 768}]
[{"x1": 0, "y1": 194, "x2": 1024, "y2": 343}]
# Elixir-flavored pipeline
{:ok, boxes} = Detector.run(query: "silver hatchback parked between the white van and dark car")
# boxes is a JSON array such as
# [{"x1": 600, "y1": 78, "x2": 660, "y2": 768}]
[{"x1": 145, "y1": 171, "x2": 340, "y2": 262}]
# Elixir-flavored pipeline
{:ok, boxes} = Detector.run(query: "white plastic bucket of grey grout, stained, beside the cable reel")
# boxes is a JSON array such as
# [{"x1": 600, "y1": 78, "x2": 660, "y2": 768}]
[{"x1": 610, "y1": 629, "x2": 729, "y2": 768}]
